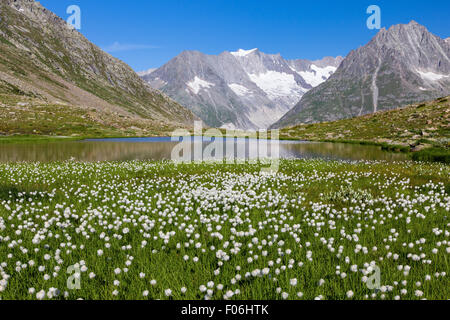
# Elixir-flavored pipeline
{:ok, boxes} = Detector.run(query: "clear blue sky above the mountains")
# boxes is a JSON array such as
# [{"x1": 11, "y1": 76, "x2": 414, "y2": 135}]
[{"x1": 40, "y1": 0, "x2": 450, "y2": 71}]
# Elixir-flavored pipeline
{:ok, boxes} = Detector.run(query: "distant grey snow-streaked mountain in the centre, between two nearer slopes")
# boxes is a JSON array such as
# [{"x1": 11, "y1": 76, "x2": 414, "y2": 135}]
[{"x1": 142, "y1": 49, "x2": 343, "y2": 129}]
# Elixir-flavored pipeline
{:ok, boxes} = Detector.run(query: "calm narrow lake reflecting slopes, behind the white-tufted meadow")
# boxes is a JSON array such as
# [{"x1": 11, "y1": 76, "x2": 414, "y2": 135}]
[{"x1": 0, "y1": 138, "x2": 407, "y2": 162}]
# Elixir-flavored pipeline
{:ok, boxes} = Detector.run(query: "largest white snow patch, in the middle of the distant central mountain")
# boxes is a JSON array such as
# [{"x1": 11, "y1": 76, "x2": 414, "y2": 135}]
[{"x1": 249, "y1": 71, "x2": 306, "y2": 99}]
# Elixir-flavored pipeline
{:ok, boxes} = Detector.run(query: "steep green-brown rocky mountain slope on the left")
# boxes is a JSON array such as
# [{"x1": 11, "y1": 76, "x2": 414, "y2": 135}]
[{"x1": 0, "y1": 0, "x2": 196, "y2": 136}]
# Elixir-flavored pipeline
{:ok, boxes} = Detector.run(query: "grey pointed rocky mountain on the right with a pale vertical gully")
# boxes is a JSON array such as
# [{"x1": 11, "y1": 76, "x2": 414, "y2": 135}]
[{"x1": 273, "y1": 21, "x2": 450, "y2": 128}]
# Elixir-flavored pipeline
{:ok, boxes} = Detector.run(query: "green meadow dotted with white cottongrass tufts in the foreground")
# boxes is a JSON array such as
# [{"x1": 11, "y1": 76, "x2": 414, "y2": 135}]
[{"x1": 0, "y1": 160, "x2": 450, "y2": 300}]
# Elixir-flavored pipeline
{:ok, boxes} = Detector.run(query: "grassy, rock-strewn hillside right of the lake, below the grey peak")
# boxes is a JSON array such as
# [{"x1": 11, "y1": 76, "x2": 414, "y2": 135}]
[{"x1": 280, "y1": 97, "x2": 450, "y2": 158}]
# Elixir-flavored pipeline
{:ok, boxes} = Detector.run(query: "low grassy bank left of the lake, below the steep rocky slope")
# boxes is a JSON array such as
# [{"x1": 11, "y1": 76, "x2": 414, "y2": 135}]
[{"x1": 0, "y1": 93, "x2": 189, "y2": 141}]
